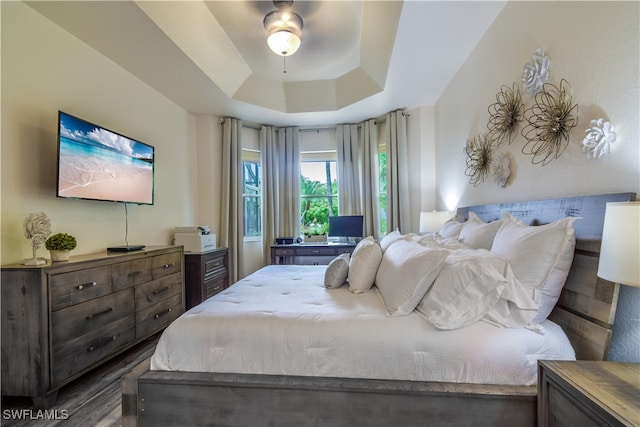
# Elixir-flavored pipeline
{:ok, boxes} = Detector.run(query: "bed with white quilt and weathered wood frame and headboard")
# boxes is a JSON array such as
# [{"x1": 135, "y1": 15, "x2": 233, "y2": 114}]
[{"x1": 122, "y1": 193, "x2": 634, "y2": 426}]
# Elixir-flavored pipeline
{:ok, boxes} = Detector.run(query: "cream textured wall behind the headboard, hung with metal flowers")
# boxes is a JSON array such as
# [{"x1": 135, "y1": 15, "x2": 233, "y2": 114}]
[{"x1": 435, "y1": 1, "x2": 640, "y2": 361}]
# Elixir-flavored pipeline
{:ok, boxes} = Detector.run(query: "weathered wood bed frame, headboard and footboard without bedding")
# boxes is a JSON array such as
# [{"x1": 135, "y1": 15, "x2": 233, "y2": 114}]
[{"x1": 122, "y1": 193, "x2": 635, "y2": 427}]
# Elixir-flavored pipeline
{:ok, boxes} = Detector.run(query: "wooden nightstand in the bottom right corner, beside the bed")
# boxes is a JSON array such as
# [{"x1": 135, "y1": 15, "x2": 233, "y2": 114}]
[{"x1": 538, "y1": 360, "x2": 640, "y2": 427}]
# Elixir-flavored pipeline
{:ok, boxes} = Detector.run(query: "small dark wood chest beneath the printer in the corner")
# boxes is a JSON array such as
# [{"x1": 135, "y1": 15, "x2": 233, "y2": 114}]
[{"x1": 184, "y1": 248, "x2": 229, "y2": 310}]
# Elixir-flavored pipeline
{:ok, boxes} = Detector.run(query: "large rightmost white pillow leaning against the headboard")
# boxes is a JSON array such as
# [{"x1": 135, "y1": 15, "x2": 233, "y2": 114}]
[{"x1": 491, "y1": 213, "x2": 577, "y2": 323}]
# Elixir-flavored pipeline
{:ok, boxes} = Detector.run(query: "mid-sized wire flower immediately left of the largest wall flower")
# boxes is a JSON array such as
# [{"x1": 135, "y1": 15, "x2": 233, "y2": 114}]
[{"x1": 487, "y1": 83, "x2": 524, "y2": 148}]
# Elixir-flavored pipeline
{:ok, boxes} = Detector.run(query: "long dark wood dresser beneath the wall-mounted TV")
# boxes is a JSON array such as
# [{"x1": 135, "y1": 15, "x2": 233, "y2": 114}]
[{"x1": 0, "y1": 246, "x2": 184, "y2": 408}]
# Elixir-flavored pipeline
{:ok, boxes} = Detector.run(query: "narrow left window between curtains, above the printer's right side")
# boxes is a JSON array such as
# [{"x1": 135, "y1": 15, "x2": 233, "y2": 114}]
[{"x1": 242, "y1": 160, "x2": 262, "y2": 237}]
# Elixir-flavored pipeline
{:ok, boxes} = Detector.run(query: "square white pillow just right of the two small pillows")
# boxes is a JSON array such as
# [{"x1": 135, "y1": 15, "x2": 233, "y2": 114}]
[{"x1": 376, "y1": 240, "x2": 449, "y2": 316}]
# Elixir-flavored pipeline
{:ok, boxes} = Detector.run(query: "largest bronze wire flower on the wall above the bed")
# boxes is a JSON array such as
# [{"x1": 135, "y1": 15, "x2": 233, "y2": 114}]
[{"x1": 522, "y1": 79, "x2": 578, "y2": 166}]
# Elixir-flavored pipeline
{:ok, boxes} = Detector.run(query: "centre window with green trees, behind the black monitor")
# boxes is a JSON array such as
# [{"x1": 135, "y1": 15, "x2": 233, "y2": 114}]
[{"x1": 300, "y1": 160, "x2": 338, "y2": 235}]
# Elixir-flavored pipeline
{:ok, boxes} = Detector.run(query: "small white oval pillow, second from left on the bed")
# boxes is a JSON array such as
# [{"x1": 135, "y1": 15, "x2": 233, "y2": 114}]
[{"x1": 349, "y1": 236, "x2": 382, "y2": 294}]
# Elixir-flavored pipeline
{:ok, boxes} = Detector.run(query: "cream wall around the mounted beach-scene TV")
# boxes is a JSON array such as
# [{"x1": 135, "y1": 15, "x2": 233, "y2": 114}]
[{"x1": 0, "y1": 2, "x2": 197, "y2": 264}]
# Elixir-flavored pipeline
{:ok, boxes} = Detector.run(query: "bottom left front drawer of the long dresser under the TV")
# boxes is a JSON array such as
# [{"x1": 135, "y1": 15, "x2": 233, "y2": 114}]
[{"x1": 51, "y1": 313, "x2": 135, "y2": 387}]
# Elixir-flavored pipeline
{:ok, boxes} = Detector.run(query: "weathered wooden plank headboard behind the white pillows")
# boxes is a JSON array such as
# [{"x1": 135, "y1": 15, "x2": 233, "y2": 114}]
[{"x1": 456, "y1": 193, "x2": 635, "y2": 360}]
